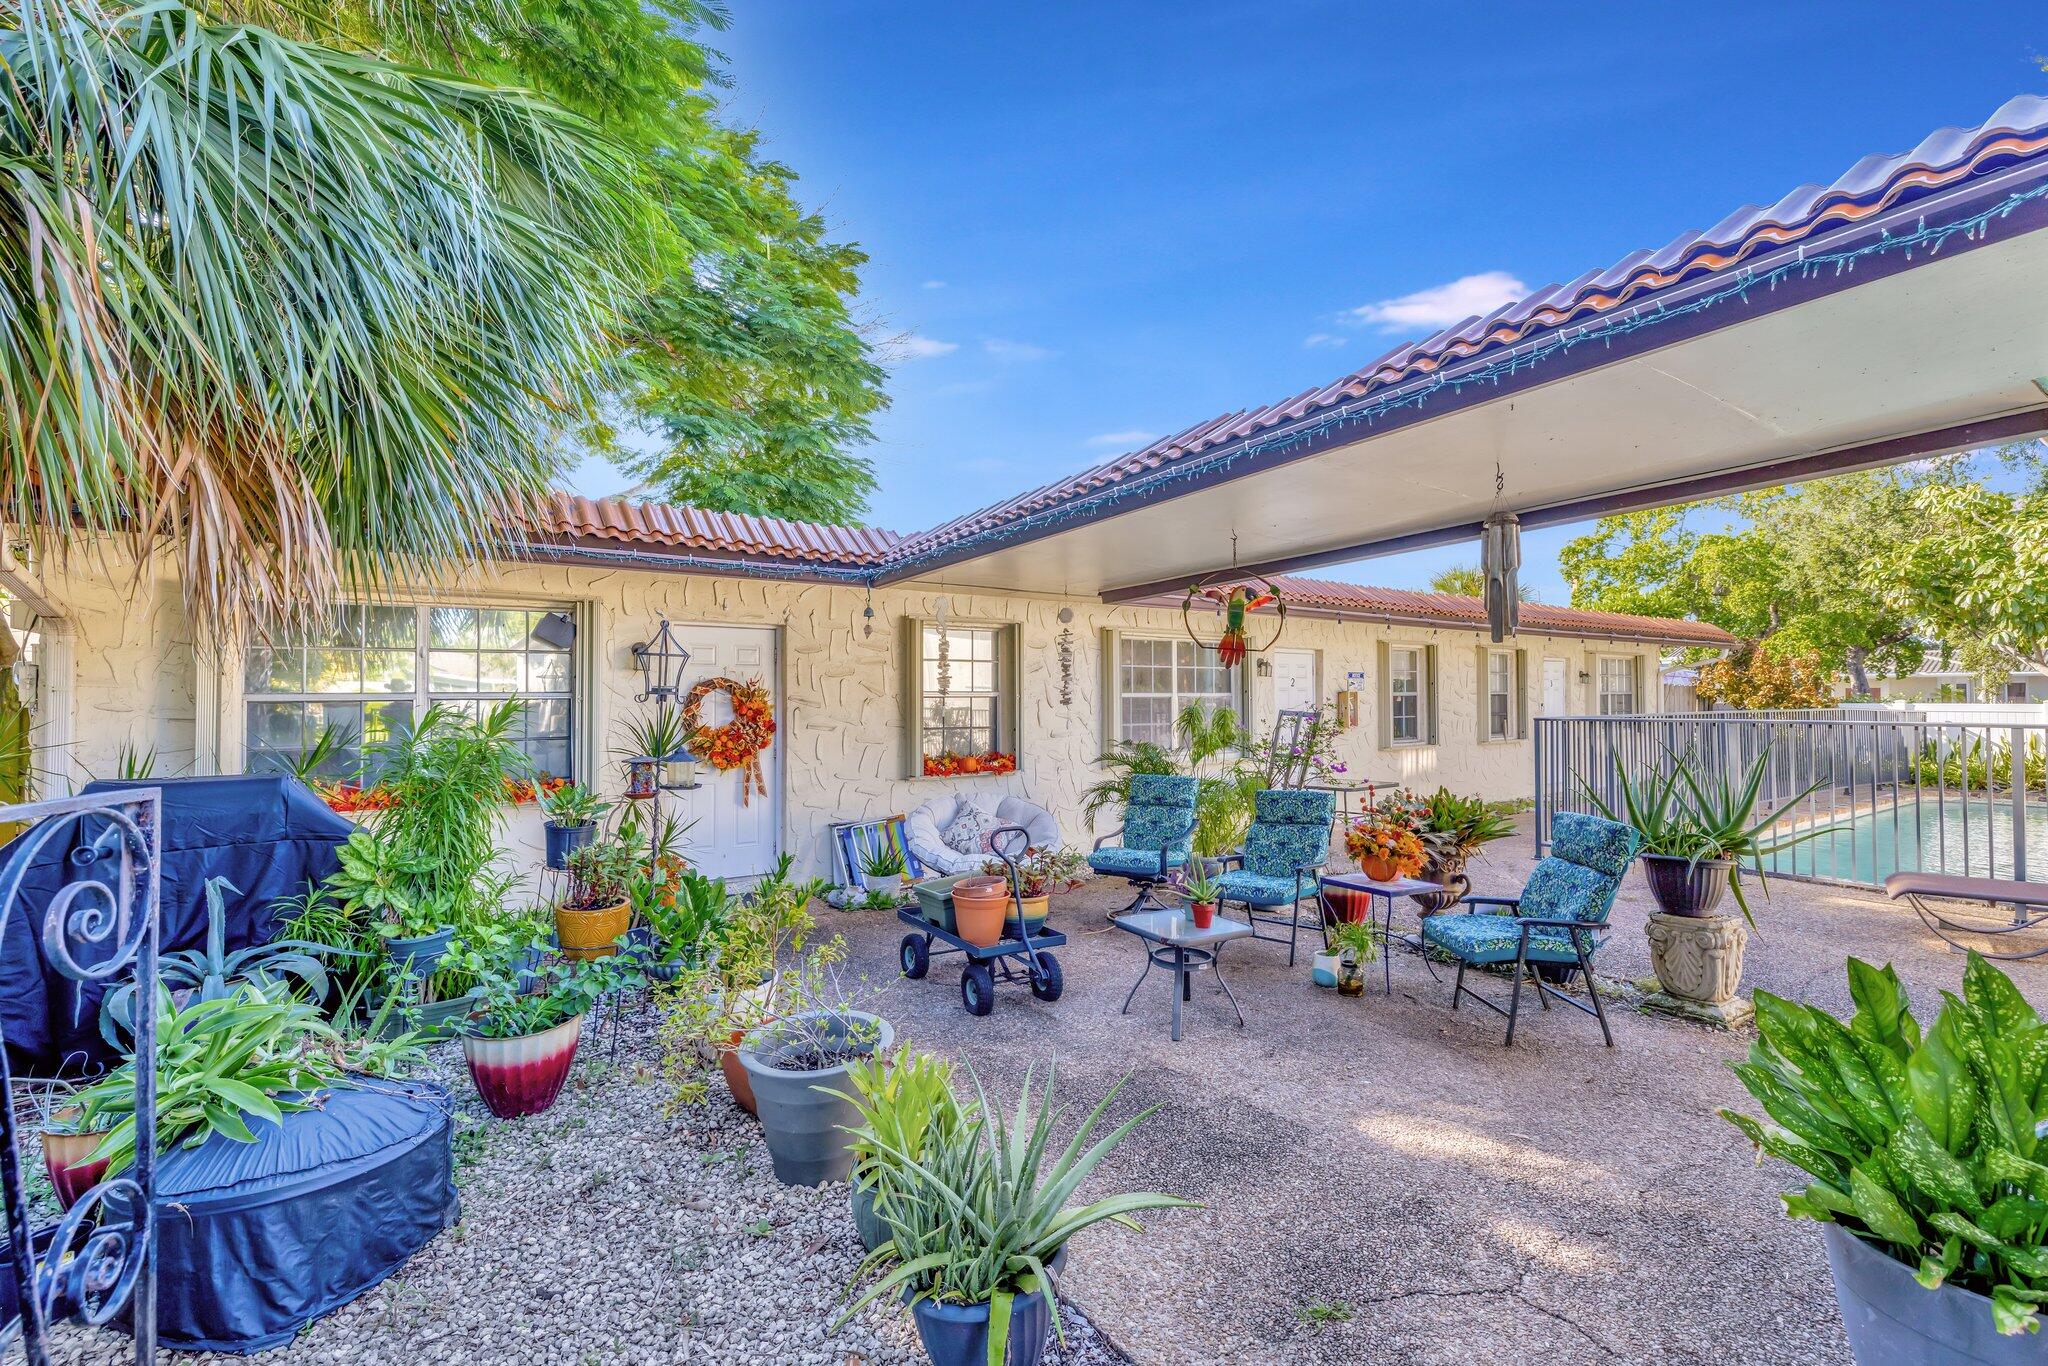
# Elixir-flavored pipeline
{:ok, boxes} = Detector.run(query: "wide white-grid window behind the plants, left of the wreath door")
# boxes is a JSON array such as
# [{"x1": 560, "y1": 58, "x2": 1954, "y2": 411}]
[{"x1": 242, "y1": 604, "x2": 575, "y2": 778}]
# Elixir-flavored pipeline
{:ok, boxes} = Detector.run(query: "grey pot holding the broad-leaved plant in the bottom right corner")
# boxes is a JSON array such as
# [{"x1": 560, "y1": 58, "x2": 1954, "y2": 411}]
[{"x1": 1821, "y1": 1225, "x2": 2042, "y2": 1366}]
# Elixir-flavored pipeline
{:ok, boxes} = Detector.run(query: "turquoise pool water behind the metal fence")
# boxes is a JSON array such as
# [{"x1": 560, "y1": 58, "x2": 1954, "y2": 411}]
[{"x1": 1763, "y1": 795, "x2": 2048, "y2": 885}]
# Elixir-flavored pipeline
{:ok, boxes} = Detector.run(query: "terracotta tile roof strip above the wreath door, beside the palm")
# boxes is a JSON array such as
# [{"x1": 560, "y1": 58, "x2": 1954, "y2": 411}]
[{"x1": 514, "y1": 492, "x2": 903, "y2": 565}]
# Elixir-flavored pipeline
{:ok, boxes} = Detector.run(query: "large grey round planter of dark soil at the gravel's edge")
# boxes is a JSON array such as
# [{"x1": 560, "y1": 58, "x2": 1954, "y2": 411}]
[{"x1": 739, "y1": 1010, "x2": 895, "y2": 1186}]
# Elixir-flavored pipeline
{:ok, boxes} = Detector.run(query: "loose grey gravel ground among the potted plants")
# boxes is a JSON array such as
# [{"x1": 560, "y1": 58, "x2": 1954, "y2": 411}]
[{"x1": 44, "y1": 1010, "x2": 1126, "y2": 1366}]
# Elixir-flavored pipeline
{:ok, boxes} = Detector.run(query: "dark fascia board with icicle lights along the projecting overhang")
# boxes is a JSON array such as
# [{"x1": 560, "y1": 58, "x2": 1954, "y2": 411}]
[{"x1": 874, "y1": 175, "x2": 2048, "y2": 573}]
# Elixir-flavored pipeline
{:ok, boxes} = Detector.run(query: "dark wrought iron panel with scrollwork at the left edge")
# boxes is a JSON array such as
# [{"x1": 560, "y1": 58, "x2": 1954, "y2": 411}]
[{"x1": 0, "y1": 786, "x2": 162, "y2": 1366}]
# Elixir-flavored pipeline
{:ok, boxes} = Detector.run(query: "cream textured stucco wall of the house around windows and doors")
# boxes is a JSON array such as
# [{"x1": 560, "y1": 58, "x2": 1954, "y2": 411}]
[{"x1": 0, "y1": 559, "x2": 1657, "y2": 872}]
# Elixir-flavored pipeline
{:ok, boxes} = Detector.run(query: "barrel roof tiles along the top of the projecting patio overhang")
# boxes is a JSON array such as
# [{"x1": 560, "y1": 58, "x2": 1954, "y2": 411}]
[{"x1": 897, "y1": 94, "x2": 2048, "y2": 555}]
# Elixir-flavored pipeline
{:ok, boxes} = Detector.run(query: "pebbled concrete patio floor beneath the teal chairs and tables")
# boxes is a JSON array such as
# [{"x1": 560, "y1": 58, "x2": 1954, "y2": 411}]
[{"x1": 825, "y1": 823, "x2": 2048, "y2": 1362}]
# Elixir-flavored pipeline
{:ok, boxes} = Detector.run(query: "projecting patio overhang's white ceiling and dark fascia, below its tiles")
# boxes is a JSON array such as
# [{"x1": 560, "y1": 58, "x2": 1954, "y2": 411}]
[{"x1": 879, "y1": 148, "x2": 2048, "y2": 602}]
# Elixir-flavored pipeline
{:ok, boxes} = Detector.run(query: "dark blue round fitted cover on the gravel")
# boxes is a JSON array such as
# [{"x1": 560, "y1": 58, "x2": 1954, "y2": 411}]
[{"x1": 146, "y1": 1079, "x2": 461, "y2": 1352}]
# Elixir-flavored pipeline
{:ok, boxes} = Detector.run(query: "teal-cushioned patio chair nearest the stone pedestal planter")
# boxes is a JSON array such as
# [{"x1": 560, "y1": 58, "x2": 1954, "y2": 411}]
[{"x1": 1421, "y1": 811, "x2": 1642, "y2": 1049}]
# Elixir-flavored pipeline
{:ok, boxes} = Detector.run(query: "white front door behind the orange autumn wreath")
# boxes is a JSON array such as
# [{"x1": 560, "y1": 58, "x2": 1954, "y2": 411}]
[{"x1": 662, "y1": 625, "x2": 788, "y2": 879}]
